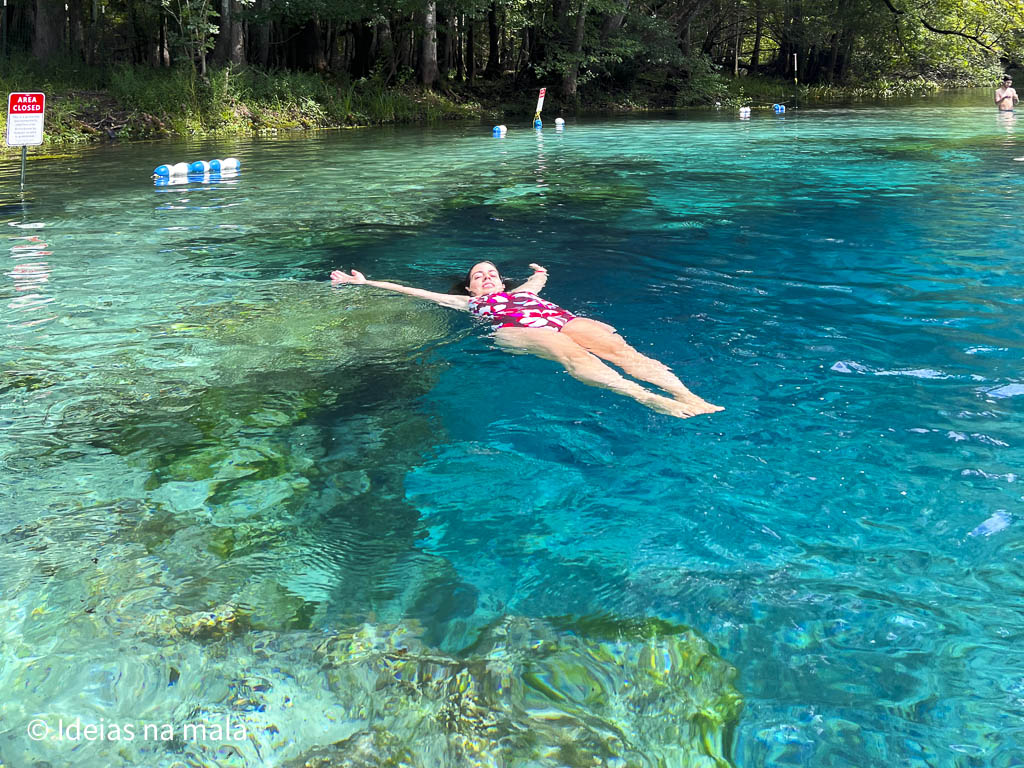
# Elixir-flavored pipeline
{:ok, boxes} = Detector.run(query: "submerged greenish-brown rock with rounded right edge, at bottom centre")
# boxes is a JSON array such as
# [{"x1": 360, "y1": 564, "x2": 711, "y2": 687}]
[{"x1": 313, "y1": 617, "x2": 741, "y2": 768}]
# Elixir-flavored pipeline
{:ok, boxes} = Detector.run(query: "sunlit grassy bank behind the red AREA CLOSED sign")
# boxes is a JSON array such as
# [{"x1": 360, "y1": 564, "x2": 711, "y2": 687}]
[{"x1": 0, "y1": 60, "x2": 486, "y2": 151}]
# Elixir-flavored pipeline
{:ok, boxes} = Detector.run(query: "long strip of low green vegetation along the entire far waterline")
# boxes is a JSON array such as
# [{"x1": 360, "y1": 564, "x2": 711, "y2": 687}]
[{"x1": 0, "y1": 58, "x2": 993, "y2": 155}]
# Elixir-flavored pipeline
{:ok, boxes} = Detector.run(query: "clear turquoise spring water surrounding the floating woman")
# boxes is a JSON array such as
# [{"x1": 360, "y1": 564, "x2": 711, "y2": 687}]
[{"x1": 0, "y1": 94, "x2": 1024, "y2": 768}]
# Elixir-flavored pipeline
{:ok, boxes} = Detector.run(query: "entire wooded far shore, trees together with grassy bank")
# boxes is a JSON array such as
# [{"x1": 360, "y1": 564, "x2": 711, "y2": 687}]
[{"x1": 0, "y1": 0, "x2": 1024, "y2": 143}]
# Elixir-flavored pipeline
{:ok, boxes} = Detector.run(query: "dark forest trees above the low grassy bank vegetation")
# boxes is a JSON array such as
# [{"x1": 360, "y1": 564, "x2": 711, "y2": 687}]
[{"x1": 0, "y1": 0, "x2": 1024, "y2": 98}]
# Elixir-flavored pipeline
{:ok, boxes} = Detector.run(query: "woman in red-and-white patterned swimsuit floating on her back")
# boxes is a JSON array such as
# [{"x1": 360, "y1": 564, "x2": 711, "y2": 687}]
[{"x1": 331, "y1": 261, "x2": 722, "y2": 419}]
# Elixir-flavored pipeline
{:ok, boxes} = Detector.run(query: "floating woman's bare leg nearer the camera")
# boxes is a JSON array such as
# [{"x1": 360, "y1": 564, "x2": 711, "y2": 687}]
[{"x1": 495, "y1": 328, "x2": 703, "y2": 419}]
